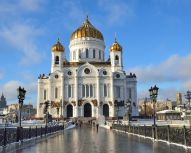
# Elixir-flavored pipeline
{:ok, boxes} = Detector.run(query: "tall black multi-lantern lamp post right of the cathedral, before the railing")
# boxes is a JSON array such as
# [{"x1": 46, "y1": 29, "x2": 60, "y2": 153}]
[{"x1": 149, "y1": 85, "x2": 159, "y2": 139}]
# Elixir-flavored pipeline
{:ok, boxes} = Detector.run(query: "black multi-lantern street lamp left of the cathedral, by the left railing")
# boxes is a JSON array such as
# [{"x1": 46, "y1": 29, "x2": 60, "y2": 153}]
[{"x1": 17, "y1": 86, "x2": 26, "y2": 127}]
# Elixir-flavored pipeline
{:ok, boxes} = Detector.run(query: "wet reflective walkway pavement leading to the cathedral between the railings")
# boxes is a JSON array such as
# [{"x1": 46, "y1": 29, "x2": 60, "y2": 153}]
[{"x1": 13, "y1": 126, "x2": 190, "y2": 153}]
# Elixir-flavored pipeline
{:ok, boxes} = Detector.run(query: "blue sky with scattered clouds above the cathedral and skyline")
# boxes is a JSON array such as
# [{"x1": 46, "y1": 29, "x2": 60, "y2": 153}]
[{"x1": 0, "y1": 0, "x2": 191, "y2": 104}]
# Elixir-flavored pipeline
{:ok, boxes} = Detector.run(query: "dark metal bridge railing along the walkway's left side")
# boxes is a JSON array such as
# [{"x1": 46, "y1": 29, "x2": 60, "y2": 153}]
[{"x1": 0, "y1": 124, "x2": 67, "y2": 146}]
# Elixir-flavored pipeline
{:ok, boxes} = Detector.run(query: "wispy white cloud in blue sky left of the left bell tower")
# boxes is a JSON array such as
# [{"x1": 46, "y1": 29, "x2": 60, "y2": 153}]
[{"x1": 0, "y1": 24, "x2": 43, "y2": 65}]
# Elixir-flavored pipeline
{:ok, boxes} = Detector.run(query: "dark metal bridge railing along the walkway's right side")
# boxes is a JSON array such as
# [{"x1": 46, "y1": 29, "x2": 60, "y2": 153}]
[{"x1": 112, "y1": 124, "x2": 191, "y2": 146}]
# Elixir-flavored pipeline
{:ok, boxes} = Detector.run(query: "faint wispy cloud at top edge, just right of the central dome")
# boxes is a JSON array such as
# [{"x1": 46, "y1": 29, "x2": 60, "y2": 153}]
[{"x1": 98, "y1": 0, "x2": 135, "y2": 25}]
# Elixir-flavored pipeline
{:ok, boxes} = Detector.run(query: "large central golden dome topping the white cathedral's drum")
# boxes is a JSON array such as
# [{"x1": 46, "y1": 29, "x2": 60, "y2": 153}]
[{"x1": 70, "y1": 16, "x2": 104, "y2": 41}]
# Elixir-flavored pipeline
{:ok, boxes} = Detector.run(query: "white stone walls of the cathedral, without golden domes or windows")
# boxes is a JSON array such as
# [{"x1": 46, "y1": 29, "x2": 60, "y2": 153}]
[{"x1": 37, "y1": 38, "x2": 138, "y2": 117}]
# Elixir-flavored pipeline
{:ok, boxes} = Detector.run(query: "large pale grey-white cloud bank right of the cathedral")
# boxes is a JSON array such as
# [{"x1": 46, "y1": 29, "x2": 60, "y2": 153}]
[{"x1": 128, "y1": 54, "x2": 191, "y2": 83}]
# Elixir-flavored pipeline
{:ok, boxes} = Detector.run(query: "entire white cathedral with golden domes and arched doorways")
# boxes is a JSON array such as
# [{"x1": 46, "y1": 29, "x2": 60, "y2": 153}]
[{"x1": 37, "y1": 17, "x2": 138, "y2": 118}]
